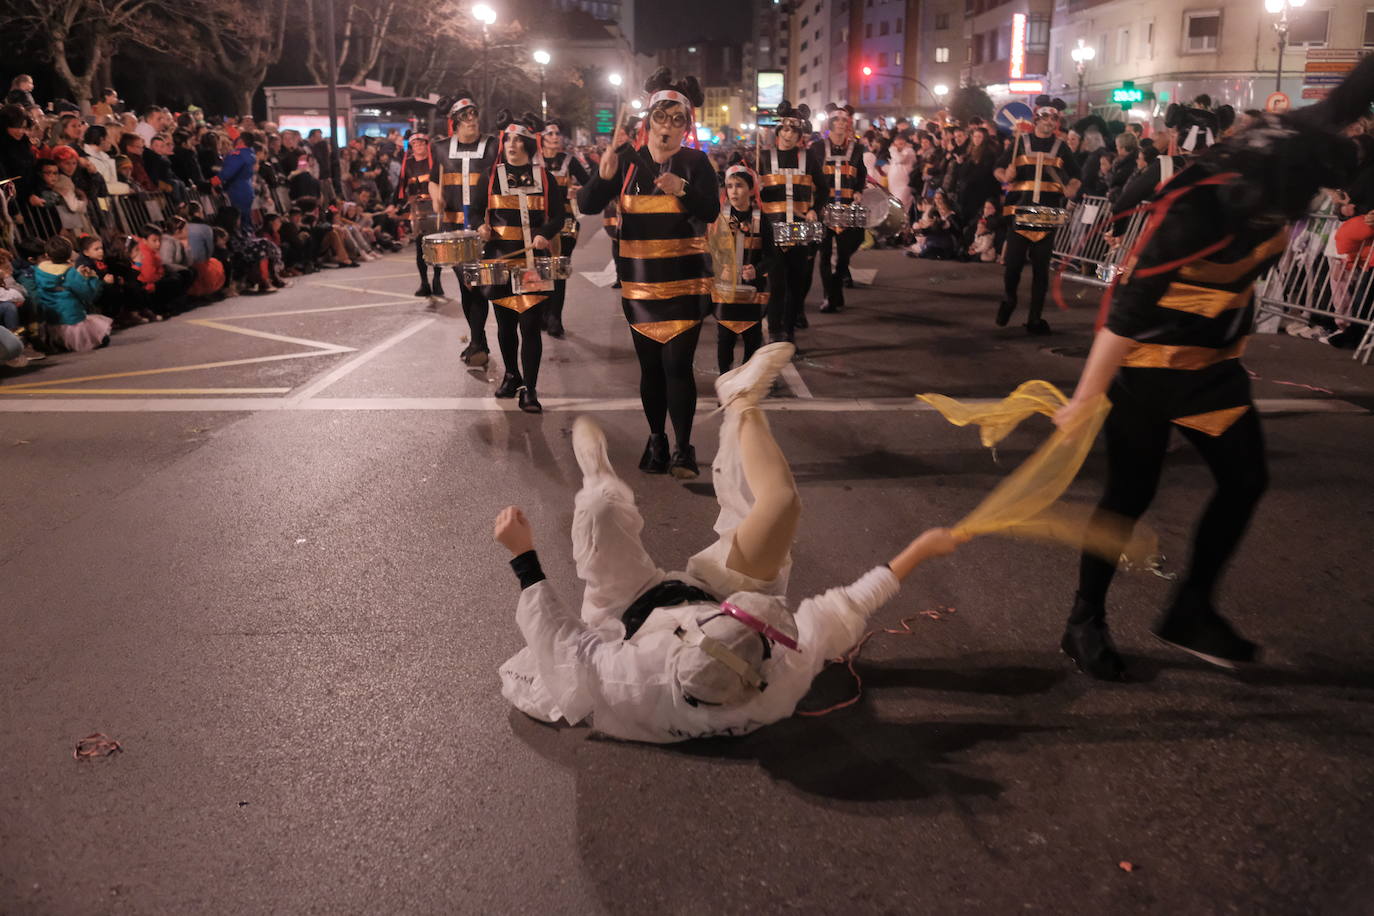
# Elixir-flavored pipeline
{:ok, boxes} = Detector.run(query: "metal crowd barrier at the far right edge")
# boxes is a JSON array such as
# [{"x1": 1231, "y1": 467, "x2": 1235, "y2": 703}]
[{"x1": 1254, "y1": 214, "x2": 1374, "y2": 365}]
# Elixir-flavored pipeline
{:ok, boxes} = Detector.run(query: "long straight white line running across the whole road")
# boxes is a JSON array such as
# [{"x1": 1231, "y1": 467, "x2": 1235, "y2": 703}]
[{"x1": 0, "y1": 398, "x2": 1352, "y2": 415}]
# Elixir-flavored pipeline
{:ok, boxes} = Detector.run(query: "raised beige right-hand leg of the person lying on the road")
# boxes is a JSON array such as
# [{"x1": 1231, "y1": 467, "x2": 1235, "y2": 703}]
[{"x1": 725, "y1": 407, "x2": 801, "y2": 582}]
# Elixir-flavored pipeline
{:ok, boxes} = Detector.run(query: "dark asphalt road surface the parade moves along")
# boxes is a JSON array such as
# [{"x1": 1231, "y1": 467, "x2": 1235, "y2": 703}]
[{"x1": 0, "y1": 221, "x2": 1374, "y2": 915}]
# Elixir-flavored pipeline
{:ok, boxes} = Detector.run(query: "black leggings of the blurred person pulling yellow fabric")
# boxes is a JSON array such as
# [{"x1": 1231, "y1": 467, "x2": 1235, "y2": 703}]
[{"x1": 1079, "y1": 376, "x2": 1268, "y2": 604}]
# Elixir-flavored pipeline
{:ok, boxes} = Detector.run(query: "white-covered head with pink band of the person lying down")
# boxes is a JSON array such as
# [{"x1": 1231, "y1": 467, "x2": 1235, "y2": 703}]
[{"x1": 673, "y1": 592, "x2": 800, "y2": 706}]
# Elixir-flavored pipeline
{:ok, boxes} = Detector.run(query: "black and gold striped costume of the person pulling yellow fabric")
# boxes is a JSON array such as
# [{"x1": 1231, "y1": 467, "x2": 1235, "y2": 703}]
[{"x1": 1079, "y1": 168, "x2": 1289, "y2": 626}]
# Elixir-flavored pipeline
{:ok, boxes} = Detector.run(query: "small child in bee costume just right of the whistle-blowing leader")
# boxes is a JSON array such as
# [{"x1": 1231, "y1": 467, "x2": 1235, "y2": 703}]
[{"x1": 710, "y1": 162, "x2": 782, "y2": 375}]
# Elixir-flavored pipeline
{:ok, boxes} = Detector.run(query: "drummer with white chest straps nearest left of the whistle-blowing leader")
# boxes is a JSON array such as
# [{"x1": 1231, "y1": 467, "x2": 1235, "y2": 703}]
[{"x1": 471, "y1": 111, "x2": 567, "y2": 413}]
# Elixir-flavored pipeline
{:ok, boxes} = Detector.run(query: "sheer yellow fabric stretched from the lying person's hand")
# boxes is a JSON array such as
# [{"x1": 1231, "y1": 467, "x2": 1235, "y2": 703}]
[{"x1": 921, "y1": 380, "x2": 1156, "y2": 566}]
